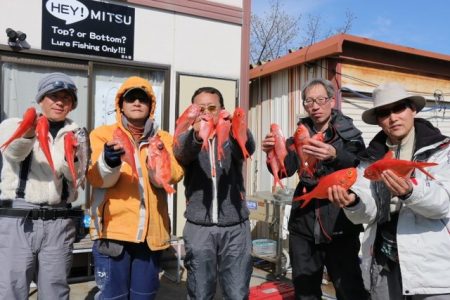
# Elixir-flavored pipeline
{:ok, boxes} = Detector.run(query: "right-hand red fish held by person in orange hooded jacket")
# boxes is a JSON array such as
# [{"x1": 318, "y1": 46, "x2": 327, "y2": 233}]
[{"x1": 147, "y1": 135, "x2": 175, "y2": 194}]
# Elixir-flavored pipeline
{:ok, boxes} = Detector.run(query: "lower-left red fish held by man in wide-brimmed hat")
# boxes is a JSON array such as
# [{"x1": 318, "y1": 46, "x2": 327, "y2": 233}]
[{"x1": 293, "y1": 168, "x2": 357, "y2": 208}]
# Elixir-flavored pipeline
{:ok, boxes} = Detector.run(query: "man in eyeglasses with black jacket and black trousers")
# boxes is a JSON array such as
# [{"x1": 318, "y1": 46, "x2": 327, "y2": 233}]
[{"x1": 262, "y1": 79, "x2": 368, "y2": 300}]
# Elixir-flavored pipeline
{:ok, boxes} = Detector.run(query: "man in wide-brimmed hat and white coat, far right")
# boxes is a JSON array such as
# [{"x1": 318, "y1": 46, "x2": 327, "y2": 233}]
[{"x1": 328, "y1": 82, "x2": 450, "y2": 300}]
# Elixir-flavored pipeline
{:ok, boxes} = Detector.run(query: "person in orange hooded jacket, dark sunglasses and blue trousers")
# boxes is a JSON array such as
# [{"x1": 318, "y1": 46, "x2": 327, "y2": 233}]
[{"x1": 87, "y1": 77, "x2": 183, "y2": 299}]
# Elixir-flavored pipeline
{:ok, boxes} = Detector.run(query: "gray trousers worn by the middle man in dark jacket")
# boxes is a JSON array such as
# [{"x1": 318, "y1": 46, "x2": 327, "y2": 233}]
[{"x1": 183, "y1": 221, "x2": 253, "y2": 300}]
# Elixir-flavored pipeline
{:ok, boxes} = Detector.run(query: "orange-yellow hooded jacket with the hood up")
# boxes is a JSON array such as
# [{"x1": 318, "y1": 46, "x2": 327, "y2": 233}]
[{"x1": 87, "y1": 77, "x2": 183, "y2": 251}]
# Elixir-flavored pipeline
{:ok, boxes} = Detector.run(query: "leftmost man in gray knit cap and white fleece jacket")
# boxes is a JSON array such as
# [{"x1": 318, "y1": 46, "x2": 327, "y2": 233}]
[{"x1": 0, "y1": 73, "x2": 82, "y2": 300}]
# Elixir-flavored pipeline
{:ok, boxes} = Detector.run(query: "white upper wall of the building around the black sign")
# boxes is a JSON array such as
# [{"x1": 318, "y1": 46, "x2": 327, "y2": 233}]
[{"x1": 0, "y1": 0, "x2": 242, "y2": 130}]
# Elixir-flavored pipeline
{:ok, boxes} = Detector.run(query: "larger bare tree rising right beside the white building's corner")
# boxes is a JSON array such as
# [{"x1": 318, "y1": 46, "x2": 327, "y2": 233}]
[{"x1": 250, "y1": 0, "x2": 300, "y2": 62}]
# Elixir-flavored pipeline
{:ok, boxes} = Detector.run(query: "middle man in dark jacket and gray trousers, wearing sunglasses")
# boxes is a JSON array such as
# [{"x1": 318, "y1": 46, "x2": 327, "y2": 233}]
[{"x1": 174, "y1": 87, "x2": 255, "y2": 300}]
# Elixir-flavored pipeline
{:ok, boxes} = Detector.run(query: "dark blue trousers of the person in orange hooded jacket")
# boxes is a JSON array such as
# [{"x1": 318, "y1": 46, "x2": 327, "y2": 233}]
[{"x1": 92, "y1": 241, "x2": 160, "y2": 300}]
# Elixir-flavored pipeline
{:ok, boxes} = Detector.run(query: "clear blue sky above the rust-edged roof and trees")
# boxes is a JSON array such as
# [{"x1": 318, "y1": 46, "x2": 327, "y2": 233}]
[{"x1": 252, "y1": 0, "x2": 450, "y2": 55}]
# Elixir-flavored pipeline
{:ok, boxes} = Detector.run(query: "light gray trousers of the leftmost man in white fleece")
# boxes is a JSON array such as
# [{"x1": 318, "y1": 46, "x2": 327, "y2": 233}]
[{"x1": 0, "y1": 200, "x2": 75, "y2": 300}]
